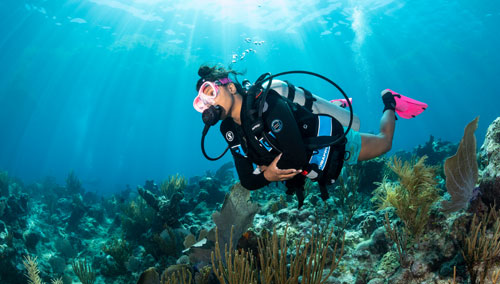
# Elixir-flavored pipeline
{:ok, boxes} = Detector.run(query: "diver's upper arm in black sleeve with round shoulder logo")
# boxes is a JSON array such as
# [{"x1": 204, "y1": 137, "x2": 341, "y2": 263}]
[{"x1": 265, "y1": 94, "x2": 307, "y2": 170}]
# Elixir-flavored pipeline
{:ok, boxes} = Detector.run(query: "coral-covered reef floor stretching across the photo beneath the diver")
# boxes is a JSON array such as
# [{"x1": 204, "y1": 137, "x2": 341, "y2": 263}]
[{"x1": 5, "y1": 118, "x2": 500, "y2": 284}]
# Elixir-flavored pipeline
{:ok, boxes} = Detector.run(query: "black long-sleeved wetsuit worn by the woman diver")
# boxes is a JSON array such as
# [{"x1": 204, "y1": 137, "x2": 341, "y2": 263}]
[{"x1": 220, "y1": 90, "x2": 341, "y2": 207}]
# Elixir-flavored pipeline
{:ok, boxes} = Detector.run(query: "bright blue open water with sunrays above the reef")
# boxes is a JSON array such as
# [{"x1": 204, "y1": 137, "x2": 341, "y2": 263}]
[{"x1": 0, "y1": 0, "x2": 500, "y2": 193}]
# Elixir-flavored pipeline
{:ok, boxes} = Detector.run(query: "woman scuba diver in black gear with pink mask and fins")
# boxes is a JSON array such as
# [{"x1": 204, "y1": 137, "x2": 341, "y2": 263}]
[{"x1": 193, "y1": 65, "x2": 427, "y2": 208}]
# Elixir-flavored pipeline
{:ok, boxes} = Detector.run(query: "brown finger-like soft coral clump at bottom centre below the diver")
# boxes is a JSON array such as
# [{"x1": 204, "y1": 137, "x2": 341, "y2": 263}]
[{"x1": 212, "y1": 224, "x2": 344, "y2": 284}]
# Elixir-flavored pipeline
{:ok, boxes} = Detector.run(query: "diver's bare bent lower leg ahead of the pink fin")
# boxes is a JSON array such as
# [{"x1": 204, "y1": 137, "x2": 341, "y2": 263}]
[{"x1": 358, "y1": 109, "x2": 396, "y2": 161}]
